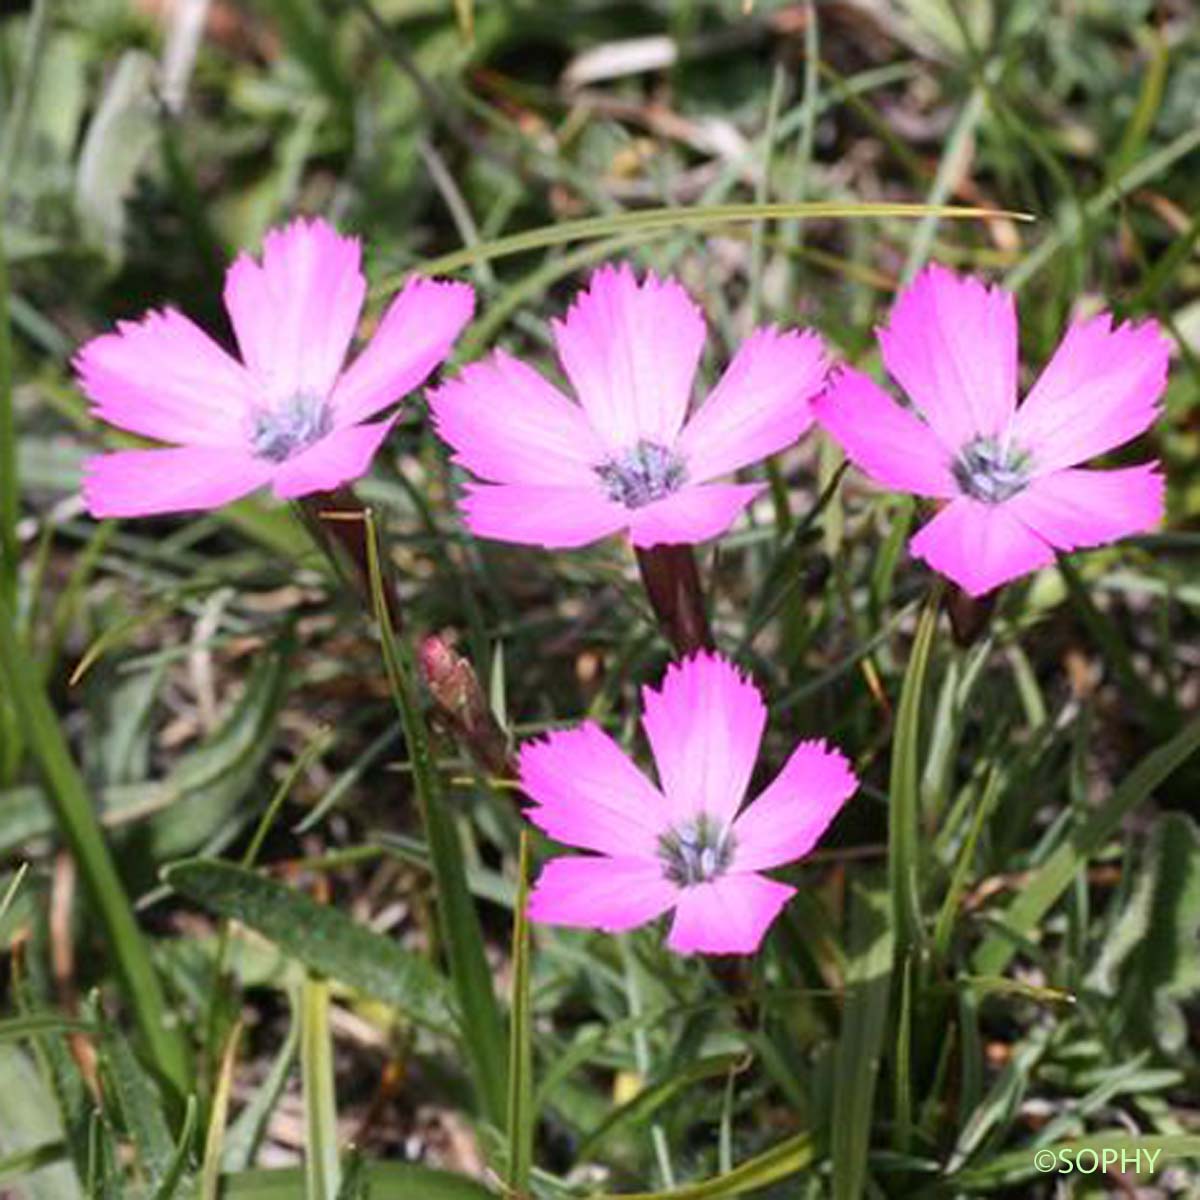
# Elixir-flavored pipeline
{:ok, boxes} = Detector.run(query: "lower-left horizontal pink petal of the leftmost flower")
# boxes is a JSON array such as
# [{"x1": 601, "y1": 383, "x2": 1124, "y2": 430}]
[{"x1": 83, "y1": 446, "x2": 274, "y2": 518}]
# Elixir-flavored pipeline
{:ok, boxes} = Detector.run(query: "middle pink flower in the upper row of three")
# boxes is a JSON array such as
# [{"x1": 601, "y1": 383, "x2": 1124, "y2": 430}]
[{"x1": 430, "y1": 266, "x2": 826, "y2": 547}]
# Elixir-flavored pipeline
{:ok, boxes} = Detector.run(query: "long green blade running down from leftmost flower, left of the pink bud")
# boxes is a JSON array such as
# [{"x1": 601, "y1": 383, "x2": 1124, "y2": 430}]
[{"x1": 364, "y1": 510, "x2": 506, "y2": 1127}]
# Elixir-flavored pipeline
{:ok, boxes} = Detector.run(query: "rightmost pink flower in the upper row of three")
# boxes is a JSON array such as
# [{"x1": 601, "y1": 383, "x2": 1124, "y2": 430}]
[{"x1": 814, "y1": 266, "x2": 1169, "y2": 596}]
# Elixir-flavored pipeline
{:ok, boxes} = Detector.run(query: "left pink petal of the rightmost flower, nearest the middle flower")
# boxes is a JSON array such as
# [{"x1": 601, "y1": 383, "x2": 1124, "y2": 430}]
[{"x1": 812, "y1": 367, "x2": 959, "y2": 498}]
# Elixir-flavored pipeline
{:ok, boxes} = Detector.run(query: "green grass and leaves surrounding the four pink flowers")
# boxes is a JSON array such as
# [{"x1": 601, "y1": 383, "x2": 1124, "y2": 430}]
[{"x1": 0, "y1": 0, "x2": 1200, "y2": 1200}]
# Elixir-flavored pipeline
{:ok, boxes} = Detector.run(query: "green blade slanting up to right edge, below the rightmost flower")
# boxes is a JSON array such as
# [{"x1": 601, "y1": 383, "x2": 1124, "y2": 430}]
[{"x1": 972, "y1": 718, "x2": 1200, "y2": 974}]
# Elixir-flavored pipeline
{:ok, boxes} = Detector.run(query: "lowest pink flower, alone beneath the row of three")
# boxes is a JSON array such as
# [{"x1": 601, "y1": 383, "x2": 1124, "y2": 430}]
[{"x1": 520, "y1": 654, "x2": 858, "y2": 954}]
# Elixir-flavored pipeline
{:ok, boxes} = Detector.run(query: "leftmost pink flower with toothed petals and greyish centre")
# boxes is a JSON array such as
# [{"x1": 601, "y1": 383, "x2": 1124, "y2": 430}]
[{"x1": 76, "y1": 220, "x2": 474, "y2": 517}]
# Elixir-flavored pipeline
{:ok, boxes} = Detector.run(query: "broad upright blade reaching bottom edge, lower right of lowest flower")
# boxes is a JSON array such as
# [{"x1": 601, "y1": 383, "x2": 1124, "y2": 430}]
[{"x1": 829, "y1": 890, "x2": 895, "y2": 1200}]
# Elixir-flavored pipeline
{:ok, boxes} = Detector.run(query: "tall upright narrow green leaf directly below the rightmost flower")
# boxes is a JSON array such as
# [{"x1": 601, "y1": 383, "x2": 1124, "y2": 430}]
[{"x1": 888, "y1": 588, "x2": 941, "y2": 953}]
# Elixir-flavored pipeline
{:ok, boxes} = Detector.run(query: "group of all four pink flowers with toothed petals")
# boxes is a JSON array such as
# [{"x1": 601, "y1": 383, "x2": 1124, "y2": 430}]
[{"x1": 76, "y1": 220, "x2": 1169, "y2": 954}]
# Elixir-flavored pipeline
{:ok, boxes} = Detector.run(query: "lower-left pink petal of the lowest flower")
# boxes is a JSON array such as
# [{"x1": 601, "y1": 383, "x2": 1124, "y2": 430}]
[{"x1": 528, "y1": 856, "x2": 679, "y2": 934}]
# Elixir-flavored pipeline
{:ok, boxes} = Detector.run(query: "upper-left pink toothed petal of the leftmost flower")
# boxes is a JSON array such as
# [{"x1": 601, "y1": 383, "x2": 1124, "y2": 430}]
[{"x1": 74, "y1": 308, "x2": 258, "y2": 446}]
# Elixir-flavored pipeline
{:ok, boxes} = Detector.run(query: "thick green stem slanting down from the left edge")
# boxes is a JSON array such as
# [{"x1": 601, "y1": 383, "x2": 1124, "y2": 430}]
[{"x1": 0, "y1": 595, "x2": 190, "y2": 1096}]
